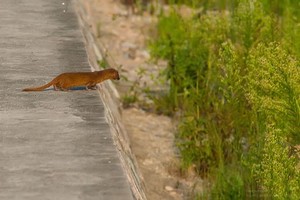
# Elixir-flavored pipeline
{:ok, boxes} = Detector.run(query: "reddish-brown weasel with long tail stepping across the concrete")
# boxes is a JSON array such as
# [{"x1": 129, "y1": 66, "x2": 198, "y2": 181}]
[{"x1": 23, "y1": 68, "x2": 120, "y2": 92}]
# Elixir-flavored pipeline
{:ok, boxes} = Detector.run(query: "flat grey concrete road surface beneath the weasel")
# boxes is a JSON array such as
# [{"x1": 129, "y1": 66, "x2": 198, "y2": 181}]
[{"x1": 0, "y1": 0, "x2": 132, "y2": 200}]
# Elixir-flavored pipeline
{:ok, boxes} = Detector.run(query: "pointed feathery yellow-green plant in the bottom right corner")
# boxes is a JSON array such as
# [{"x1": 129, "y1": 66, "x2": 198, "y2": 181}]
[{"x1": 251, "y1": 124, "x2": 300, "y2": 199}]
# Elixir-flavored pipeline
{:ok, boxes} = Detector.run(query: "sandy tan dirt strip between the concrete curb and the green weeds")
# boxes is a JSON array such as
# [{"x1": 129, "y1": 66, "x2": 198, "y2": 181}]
[{"x1": 79, "y1": 0, "x2": 202, "y2": 200}]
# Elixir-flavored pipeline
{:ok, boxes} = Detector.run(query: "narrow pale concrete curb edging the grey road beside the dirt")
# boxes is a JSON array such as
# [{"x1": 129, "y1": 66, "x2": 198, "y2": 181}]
[{"x1": 75, "y1": 1, "x2": 147, "y2": 200}]
